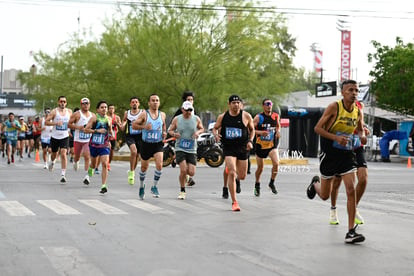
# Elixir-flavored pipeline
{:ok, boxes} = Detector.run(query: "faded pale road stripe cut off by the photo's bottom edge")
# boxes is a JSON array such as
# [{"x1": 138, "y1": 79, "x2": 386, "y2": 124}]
[{"x1": 40, "y1": 246, "x2": 105, "y2": 276}]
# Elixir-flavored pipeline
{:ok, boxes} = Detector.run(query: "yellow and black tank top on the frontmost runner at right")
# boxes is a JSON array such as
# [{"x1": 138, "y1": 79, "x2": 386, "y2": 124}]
[{"x1": 321, "y1": 100, "x2": 361, "y2": 151}]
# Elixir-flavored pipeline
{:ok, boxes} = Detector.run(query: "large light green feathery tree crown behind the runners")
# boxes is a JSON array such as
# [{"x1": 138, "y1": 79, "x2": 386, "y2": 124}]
[{"x1": 22, "y1": 0, "x2": 306, "y2": 112}]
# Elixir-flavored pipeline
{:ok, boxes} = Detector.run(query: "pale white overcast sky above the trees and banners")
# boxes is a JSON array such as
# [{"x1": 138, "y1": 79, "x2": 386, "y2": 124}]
[{"x1": 0, "y1": 0, "x2": 414, "y2": 83}]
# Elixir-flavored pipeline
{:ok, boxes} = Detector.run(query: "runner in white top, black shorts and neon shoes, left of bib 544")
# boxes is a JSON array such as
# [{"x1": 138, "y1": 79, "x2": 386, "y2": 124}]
[{"x1": 120, "y1": 96, "x2": 145, "y2": 185}]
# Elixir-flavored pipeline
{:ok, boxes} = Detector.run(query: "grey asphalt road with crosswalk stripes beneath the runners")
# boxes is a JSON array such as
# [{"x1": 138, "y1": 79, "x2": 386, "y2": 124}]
[{"x1": 0, "y1": 155, "x2": 414, "y2": 276}]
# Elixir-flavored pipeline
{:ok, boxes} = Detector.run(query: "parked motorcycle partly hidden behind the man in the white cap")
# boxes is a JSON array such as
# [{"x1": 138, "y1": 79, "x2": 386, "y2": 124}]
[{"x1": 162, "y1": 132, "x2": 224, "y2": 168}]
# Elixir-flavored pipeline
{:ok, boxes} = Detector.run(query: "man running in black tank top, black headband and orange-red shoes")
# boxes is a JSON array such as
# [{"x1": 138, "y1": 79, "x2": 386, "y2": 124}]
[{"x1": 213, "y1": 95, "x2": 255, "y2": 211}]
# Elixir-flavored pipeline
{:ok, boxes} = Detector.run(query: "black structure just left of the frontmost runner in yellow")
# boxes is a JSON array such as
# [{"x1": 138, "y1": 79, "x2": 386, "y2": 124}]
[{"x1": 280, "y1": 106, "x2": 323, "y2": 157}]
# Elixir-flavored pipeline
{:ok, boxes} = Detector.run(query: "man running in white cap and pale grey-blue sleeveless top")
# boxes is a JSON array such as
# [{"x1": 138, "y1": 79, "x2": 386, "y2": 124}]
[{"x1": 168, "y1": 101, "x2": 204, "y2": 199}]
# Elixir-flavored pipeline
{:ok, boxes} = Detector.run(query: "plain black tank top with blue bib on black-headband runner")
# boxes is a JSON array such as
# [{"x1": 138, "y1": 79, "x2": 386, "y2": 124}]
[{"x1": 220, "y1": 110, "x2": 249, "y2": 148}]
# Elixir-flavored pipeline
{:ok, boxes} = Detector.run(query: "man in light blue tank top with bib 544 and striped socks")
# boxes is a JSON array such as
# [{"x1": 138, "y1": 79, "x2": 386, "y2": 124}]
[{"x1": 132, "y1": 94, "x2": 167, "y2": 199}]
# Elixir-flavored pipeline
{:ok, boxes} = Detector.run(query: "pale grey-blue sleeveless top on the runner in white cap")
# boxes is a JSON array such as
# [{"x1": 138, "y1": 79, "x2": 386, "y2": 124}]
[{"x1": 175, "y1": 114, "x2": 197, "y2": 153}]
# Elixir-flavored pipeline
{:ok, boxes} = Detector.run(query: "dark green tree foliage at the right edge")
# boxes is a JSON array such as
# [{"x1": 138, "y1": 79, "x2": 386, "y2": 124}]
[{"x1": 368, "y1": 37, "x2": 414, "y2": 115}]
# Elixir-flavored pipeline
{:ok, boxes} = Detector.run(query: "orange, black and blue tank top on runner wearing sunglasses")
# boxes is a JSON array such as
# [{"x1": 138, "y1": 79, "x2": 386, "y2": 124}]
[{"x1": 256, "y1": 112, "x2": 279, "y2": 149}]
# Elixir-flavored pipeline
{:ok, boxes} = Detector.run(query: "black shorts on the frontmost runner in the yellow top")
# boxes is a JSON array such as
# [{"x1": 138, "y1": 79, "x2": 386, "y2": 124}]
[{"x1": 319, "y1": 150, "x2": 357, "y2": 179}]
